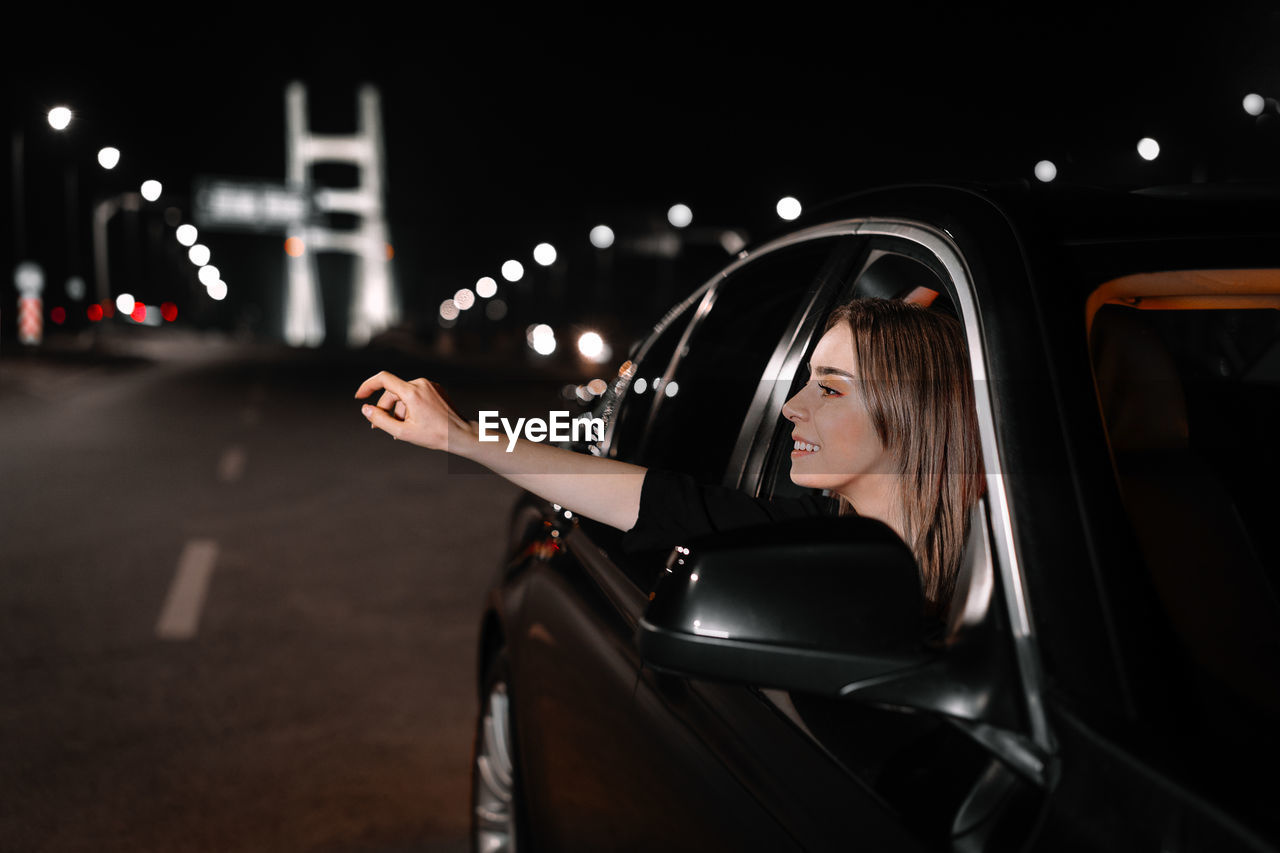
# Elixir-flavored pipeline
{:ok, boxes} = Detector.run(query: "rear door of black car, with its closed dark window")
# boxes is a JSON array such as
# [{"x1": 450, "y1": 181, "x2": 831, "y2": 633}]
[{"x1": 512, "y1": 234, "x2": 849, "y2": 849}]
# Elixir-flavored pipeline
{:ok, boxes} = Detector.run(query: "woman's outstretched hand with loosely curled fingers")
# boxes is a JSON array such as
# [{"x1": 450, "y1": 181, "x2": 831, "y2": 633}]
[{"x1": 356, "y1": 370, "x2": 471, "y2": 452}]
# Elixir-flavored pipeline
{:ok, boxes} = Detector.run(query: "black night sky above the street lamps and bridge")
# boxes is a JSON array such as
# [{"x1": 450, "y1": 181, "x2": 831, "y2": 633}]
[{"x1": 0, "y1": 3, "x2": 1280, "y2": 343}]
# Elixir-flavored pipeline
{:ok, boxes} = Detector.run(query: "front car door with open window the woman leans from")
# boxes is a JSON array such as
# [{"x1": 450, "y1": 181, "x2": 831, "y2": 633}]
[{"x1": 622, "y1": 222, "x2": 1046, "y2": 850}]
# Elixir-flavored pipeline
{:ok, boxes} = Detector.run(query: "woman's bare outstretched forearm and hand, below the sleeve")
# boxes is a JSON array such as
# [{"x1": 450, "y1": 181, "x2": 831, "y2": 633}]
[{"x1": 356, "y1": 370, "x2": 646, "y2": 530}]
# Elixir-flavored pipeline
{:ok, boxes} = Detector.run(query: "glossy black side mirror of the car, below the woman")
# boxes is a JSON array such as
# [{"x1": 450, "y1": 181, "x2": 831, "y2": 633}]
[{"x1": 636, "y1": 517, "x2": 941, "y2": 695}]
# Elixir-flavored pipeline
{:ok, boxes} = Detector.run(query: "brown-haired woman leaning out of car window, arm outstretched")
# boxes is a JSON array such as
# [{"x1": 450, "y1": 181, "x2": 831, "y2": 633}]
[{"x1": 356, "y1": 300, "x2": 984, "y2": 613}]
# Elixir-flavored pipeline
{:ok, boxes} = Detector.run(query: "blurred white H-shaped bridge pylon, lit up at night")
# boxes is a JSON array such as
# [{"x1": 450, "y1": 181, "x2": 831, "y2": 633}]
[{"x1": 284, "y1": 82, "x2": 399, "y2": 347}]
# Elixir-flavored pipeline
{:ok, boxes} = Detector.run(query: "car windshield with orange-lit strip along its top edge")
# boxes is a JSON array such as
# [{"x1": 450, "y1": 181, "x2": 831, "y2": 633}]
[{"x1": 1088, "y1": 270, "x2": 1280, "y2": 816}]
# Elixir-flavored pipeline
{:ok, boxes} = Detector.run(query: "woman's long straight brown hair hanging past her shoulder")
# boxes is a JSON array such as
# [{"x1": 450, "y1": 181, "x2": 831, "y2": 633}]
[{"x1": 827, "y1": 298, "x2": 986, "y2": 615}]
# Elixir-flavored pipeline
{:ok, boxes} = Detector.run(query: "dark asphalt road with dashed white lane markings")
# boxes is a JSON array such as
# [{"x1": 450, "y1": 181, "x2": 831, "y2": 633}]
[{"x1": 0, "y1": 327, "x2": 570, "y2": 852}]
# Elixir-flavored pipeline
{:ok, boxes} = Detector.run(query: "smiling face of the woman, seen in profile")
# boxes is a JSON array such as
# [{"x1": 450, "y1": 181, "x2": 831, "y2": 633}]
[{"x1": 782, "y1": 323, "x2": 896, "y2": 507}]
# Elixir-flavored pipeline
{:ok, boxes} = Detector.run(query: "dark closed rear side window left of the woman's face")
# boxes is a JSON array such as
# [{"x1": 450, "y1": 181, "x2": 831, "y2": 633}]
[{"x1": 632, "y1": 241, "x2": 833, "y2": 483}]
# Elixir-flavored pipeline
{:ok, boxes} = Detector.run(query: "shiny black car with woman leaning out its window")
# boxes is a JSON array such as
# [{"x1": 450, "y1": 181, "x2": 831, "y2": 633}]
[{"x1": 474, "y1": 184, "x2": 1280, "y2": 853}]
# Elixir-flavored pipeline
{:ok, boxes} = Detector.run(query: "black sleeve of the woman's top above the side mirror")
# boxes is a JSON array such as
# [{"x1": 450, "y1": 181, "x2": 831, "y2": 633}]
[{"x1": 622, "y1": 469, "x2": 836, "y2": 551}]
